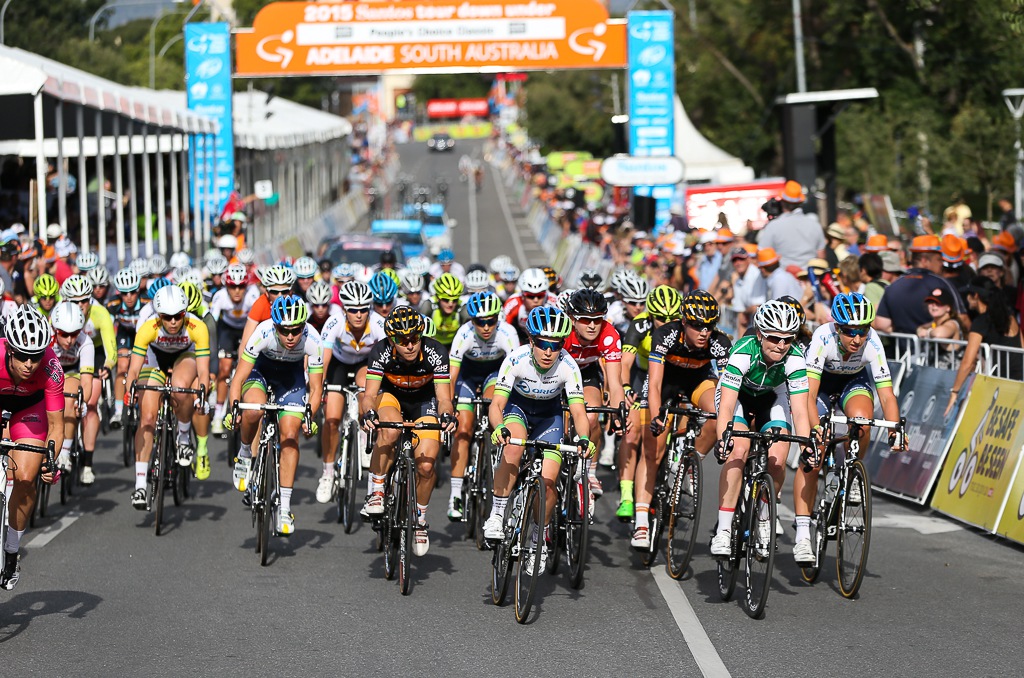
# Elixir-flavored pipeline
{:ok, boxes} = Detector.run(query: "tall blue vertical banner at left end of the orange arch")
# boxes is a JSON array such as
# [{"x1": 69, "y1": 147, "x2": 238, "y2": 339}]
[{"x1": 185, "y1": 23, "x2": 234, "y2": 225}]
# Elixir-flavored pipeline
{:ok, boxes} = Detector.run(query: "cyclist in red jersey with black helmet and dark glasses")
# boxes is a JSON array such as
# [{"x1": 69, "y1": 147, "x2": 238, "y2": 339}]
[{"x1": 565, "y1": 288, "x2": 626, "y2": 498}]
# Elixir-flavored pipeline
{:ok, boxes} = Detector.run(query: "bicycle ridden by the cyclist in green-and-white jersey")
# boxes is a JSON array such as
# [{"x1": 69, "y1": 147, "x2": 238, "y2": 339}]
[{"x1": 718, "y1": 421, "x2": 812, "y2": 619}]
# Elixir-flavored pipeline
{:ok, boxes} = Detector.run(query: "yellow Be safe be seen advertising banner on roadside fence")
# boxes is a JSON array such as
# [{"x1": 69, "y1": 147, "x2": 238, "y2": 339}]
[{"x1": 932, "y1": 375, "x2": 1024, "y2": 531}]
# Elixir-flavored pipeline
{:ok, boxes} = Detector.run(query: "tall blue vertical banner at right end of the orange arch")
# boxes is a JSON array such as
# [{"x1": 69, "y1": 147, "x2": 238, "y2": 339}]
[{"x1": 626, "y1": 10, "x2": 676, "y2": 228}]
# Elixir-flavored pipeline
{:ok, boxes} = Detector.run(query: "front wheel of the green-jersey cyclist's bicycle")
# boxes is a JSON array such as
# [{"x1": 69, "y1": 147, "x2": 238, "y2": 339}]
[{"x1": 744, "y1": 473, "x2": 777, "y2": 619}]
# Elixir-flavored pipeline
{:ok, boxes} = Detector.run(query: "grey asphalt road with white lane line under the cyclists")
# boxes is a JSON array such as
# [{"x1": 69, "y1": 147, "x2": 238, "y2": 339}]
[{"x1": 0, "y1": 140, "x2": 1024, "y2": 676}]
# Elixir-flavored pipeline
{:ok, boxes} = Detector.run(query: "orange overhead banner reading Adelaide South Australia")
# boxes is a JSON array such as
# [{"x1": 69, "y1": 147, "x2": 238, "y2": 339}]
[{"x1": 234, "y1": 0, "x2": 626, "y2": 78}]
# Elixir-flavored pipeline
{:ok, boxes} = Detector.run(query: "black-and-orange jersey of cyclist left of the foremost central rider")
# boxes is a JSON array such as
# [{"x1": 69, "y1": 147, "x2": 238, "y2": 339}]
[{"x1": 367, "y1": 337, "x2": 451, "y2": 401}]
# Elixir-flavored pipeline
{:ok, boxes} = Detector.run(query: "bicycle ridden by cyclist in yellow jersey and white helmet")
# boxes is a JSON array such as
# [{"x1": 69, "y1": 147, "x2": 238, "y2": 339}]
[{"x1": 130, "y1": 382, "x2": 206, "y2": 537}]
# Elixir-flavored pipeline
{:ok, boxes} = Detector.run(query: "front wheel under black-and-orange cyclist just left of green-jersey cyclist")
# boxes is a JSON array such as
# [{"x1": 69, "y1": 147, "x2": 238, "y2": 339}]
[{"x1": 665, "y1": 450, "x2": 703, "y2": 579}]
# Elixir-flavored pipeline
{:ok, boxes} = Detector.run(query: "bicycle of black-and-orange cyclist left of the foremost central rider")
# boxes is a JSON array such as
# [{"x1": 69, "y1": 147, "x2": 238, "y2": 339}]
[{"x1": 367, "y1": 421, "x2": 443, "y2": 595}]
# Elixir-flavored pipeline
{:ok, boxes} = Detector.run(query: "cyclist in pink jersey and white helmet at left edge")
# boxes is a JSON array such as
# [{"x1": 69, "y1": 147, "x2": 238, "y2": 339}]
[{"x1": 0, "y1": 305, "x2": 65, "y2": 591}]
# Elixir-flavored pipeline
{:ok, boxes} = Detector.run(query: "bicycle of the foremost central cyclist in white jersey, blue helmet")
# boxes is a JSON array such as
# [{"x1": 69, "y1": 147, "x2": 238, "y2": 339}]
[{"x1": 490, "y1": 438, "x2": 589, "y2": 624}]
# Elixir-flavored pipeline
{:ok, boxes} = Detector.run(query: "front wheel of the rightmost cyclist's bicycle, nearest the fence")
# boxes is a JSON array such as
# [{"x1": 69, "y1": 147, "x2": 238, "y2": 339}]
[{"x1": 836, "y1": 460, "x2": 871, "y2": 598}]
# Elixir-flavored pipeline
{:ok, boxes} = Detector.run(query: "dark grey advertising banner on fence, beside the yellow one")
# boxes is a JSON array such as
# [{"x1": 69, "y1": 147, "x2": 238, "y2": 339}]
[{"x1": 864, "y1": 367, "x2": 956, "y2": 504}]
